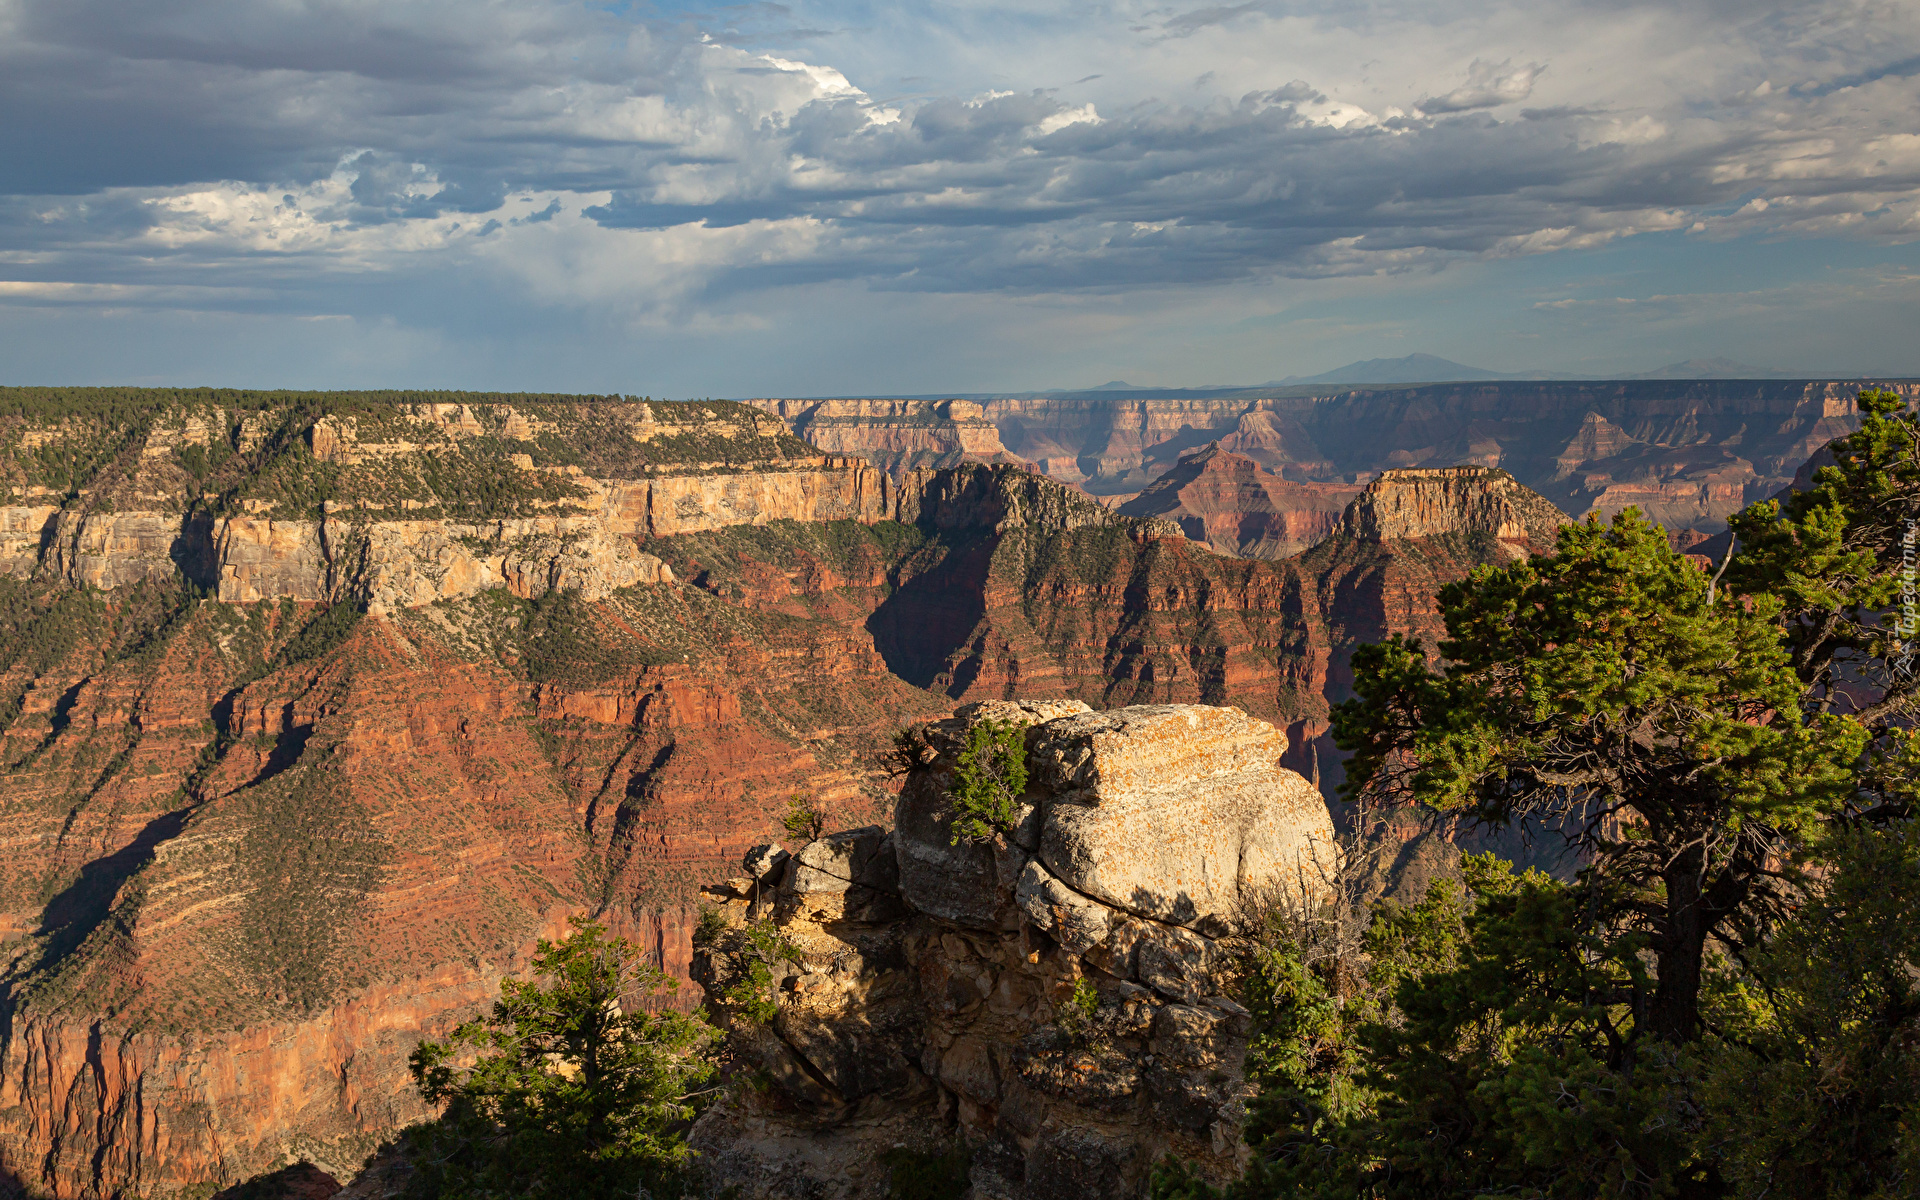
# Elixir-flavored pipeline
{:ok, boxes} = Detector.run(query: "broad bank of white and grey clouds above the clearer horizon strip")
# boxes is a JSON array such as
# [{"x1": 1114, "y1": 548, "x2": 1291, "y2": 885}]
[{"x1": 0, "y1": 0, "x2": 1920, "y2": 362}]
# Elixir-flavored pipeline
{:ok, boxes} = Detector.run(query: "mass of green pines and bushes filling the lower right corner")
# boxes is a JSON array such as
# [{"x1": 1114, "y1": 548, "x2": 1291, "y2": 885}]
[{"x1": 1156, "y1": 390, "x2": 1920, "y2": 1200}]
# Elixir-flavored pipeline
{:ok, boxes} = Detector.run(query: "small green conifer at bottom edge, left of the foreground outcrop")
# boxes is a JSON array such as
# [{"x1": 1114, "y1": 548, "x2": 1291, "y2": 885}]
[{"x1": 407, "y1": 918, "x2": 718, "y2": 1200}]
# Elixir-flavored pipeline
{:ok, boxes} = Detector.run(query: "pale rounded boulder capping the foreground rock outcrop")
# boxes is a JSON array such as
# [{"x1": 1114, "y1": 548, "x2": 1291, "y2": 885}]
[{"x1": 895, "y1": 701, "x2": 1338, "y2": 952}]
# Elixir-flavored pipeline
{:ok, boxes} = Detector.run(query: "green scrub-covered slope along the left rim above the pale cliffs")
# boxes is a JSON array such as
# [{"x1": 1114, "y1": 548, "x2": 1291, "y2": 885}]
[{"x1": 0, "y1": 388, "x2": 818, "y2": 520}]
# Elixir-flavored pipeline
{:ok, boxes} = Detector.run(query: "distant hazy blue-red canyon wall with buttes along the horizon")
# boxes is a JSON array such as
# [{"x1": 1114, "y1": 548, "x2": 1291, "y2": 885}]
[{"x1": 751, "y1": 380, "x2": 1920, "y2": 559}]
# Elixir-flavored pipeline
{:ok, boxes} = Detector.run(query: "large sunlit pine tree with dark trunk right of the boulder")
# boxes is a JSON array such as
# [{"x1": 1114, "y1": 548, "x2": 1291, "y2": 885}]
[{"x1": 1334, "y1": 509, "x2": 1868, "y2": 1044}]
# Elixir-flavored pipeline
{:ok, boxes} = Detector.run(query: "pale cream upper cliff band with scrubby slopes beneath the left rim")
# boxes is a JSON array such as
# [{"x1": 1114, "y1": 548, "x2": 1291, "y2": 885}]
[{"x1": 0, "y1": 401, "x2": 920, "y2": 612}]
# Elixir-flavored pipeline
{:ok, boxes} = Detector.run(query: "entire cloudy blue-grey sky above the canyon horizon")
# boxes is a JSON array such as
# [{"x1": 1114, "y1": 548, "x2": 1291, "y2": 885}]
[{"x1": 0, "y1": 0, "x2": 1920, "y2": 397}]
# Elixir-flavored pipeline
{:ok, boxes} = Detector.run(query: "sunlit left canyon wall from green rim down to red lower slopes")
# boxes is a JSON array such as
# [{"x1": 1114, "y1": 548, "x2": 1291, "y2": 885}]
[{"x1": 0, "y1": 390, "x2": 941, "y2": 1196}]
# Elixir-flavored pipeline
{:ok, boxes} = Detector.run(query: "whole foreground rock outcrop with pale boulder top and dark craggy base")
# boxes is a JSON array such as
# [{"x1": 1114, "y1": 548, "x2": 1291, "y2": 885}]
[{"x1": 693, "y1": 701, "x2": 1336, "y2": 1200}]
